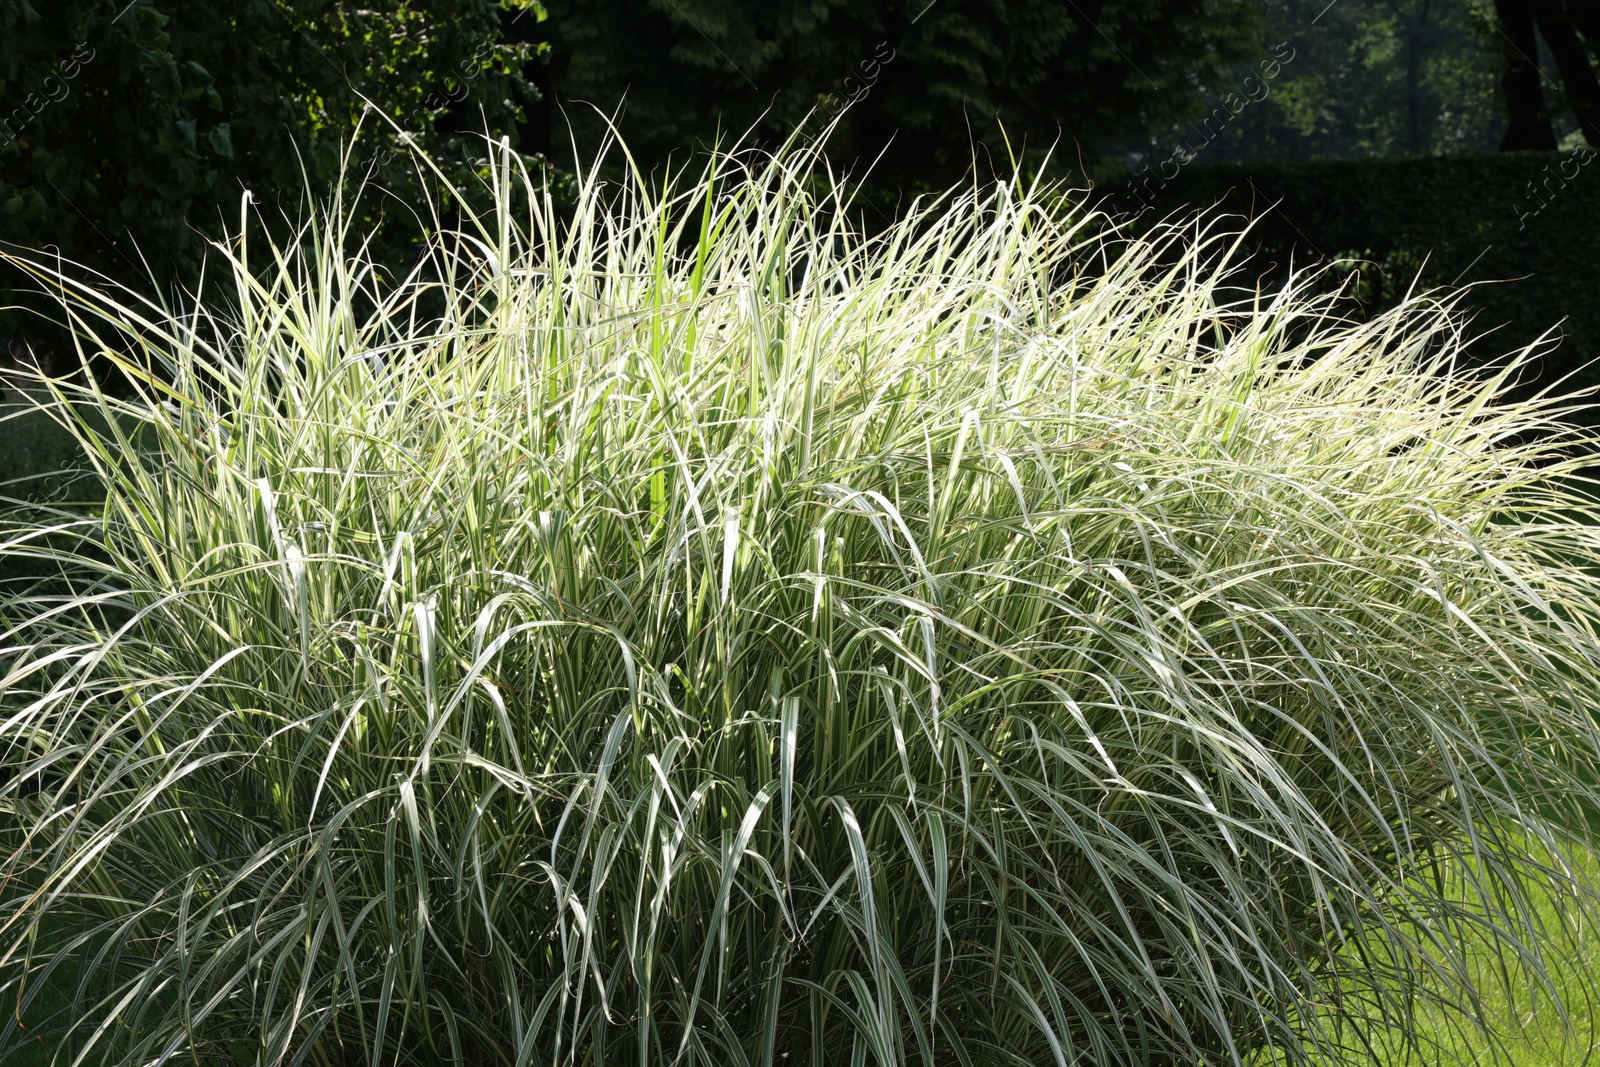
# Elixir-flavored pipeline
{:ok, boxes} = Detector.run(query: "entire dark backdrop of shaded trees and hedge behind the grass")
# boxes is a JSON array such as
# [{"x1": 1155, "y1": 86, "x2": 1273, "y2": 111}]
[{"x1": 0, "y1": 0, "x2": 1600, "y2": 425}]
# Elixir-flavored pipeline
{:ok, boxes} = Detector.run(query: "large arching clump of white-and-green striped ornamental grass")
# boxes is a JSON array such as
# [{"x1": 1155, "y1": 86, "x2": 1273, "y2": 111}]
[{"x1": 0, "y1": 135, "x2": 1600, "y2": 1067}]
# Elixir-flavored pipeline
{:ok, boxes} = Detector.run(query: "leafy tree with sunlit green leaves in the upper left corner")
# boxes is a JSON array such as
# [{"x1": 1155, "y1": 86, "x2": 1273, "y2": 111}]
[{"x1": 0, "y1": 0, "x2": 542, "y2": 355}]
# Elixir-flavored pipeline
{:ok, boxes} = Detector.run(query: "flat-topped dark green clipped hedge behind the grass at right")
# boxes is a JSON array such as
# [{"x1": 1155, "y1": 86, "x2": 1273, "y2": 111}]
[{"x1": 1104, "y1": 149, "x2": 1600, "y2": 396}]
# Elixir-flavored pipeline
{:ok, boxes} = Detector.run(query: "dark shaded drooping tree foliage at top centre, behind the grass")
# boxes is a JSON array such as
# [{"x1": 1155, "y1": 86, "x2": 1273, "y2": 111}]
[{"x1": 550, "y1": 0, "x2": 1259, "y2": 189}]
